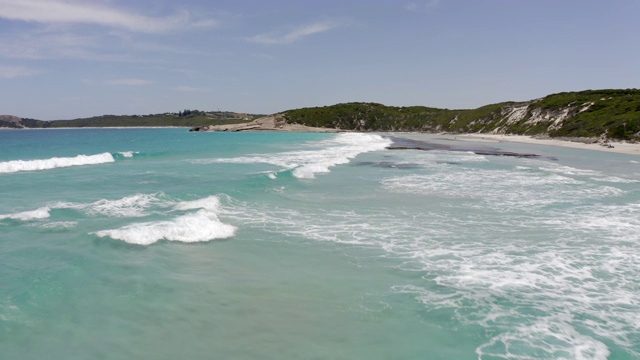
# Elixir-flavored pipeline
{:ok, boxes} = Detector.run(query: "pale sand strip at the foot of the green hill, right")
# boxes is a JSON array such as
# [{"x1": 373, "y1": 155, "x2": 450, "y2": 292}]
[{"x1": 446, "y1": 134, "x2": 640, "y2": 155}]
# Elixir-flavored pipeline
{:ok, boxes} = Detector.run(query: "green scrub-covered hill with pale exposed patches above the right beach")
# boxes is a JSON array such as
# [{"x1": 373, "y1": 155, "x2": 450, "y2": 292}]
[{"x1": 284, "y1": 89, "x2": 640, "y2": 141}]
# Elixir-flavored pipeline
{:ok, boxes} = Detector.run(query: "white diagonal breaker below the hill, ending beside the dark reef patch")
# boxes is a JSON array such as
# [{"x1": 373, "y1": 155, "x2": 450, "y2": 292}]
[{"x1": 199, "y1": 133, "x2": 391, "y2": 179}]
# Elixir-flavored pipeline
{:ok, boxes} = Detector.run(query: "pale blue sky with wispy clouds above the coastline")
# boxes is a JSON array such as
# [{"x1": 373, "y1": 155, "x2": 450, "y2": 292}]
[{"x1": 0, "y1": 0, "x2": 640, "y2": 120}]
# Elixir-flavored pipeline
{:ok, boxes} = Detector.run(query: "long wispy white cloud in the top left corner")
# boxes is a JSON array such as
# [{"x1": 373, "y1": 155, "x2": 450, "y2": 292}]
[{"x1": 0, "y1": 0, "x2": 192, "y2": 33}]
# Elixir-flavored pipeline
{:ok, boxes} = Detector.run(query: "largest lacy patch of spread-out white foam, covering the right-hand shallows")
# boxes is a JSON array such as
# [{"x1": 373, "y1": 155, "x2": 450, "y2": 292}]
[{"x1": 216, "y1": 159, "x2": 640, "y2": 360}]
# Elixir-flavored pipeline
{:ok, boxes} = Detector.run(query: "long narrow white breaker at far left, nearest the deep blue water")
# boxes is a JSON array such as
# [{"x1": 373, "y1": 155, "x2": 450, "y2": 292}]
[{"x1": 0, "y1": 153, "x2": 115, "y2": 173}]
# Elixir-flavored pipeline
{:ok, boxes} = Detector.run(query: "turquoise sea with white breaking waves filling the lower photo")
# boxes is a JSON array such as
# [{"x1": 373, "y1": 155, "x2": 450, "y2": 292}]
[{"x1": 0, "y1": 129, "x2": 640, "y2": 359}]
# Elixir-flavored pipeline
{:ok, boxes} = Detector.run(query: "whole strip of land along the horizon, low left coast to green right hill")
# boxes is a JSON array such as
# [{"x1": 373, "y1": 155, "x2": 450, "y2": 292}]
[{"x1": 0, "y1": 89, "x2": 640, "y2": 142}]
